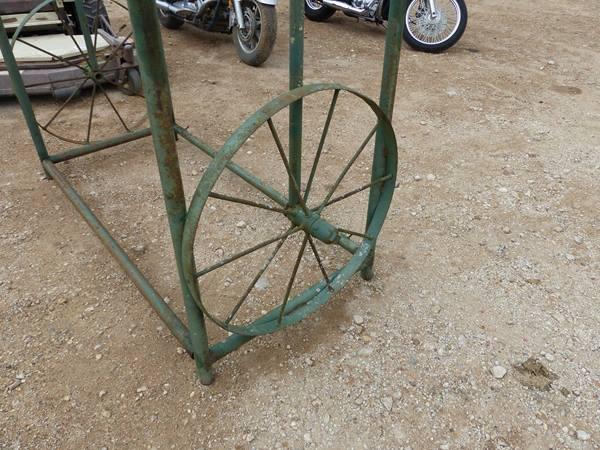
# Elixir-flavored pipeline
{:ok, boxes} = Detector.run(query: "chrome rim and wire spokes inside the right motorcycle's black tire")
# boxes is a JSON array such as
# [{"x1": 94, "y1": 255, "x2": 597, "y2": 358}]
[{"x1": 406, "y1": 0, "x2": 462, "y2": 45}]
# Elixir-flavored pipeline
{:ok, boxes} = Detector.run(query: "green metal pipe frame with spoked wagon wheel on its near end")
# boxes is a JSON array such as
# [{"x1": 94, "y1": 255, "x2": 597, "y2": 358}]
[{"x1": 0, "y1": 0, "x2": 406, "y2": 384}]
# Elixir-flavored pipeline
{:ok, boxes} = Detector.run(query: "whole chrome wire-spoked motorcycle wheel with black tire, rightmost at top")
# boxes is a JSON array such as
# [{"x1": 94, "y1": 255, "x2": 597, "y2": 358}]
[{"x1": 403, "y1": 0, "x2": 467, "y2": 53}]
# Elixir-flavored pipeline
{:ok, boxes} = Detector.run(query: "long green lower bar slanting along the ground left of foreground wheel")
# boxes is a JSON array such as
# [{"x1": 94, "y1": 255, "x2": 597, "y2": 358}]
[{"x1": 42, "y1": 159, "x2": 193, "y2": 353}]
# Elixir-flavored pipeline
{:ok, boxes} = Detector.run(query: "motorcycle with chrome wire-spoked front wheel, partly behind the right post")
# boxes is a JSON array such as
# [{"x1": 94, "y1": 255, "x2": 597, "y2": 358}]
[{"x1": 304, "y1": 0, "x2": 467, "y2": 53}]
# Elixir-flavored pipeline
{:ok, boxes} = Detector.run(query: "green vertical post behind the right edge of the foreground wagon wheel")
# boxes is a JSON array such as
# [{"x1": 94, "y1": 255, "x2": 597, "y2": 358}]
[{"x1": 361, "y1": 0, "x2": 407, "y2": 280}]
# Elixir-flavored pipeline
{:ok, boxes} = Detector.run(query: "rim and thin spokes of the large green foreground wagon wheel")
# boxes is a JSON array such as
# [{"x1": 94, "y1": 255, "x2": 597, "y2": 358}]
[{"x1": 182, "y1": 84, "x2": 397, "y2": 336}]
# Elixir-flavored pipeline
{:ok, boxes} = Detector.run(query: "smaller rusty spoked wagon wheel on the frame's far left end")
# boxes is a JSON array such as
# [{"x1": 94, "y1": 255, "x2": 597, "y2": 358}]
[{"x1": 11, "y1": 0, "x2": 146, "y2": 145}]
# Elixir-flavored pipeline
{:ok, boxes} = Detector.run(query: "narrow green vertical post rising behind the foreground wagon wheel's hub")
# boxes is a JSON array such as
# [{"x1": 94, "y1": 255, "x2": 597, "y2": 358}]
[{"x1": 289, "y1": 0, "x2": 304, "y2": 205}]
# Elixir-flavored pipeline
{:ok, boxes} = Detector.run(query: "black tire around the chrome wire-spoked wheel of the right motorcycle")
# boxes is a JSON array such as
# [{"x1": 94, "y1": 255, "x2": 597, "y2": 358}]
[{"x1": 403, "y1": 0, "x2": 468, "y2": 53}]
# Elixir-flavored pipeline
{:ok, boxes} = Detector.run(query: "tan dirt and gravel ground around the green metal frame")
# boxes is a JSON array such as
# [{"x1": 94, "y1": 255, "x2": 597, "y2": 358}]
[{"x1": 0, "y1": 0, "x2": 600, "y2": 450}]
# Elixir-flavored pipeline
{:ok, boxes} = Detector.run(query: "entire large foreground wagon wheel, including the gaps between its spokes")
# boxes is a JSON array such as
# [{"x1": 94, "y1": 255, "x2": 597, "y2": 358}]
[{"x1": 182, "y1": 84, "x2": 397, "y2": 336}]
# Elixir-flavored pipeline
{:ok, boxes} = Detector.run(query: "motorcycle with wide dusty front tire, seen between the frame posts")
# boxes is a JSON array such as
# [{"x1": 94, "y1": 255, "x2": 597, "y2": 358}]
[{"x1": 155, "y1": 0, "x2": 277, "y2": 66}]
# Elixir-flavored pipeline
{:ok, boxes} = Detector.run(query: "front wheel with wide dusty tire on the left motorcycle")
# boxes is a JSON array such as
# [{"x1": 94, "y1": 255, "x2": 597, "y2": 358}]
[{"x1": 233, "y1": 0, "x2": 277, "y2": 66}]
